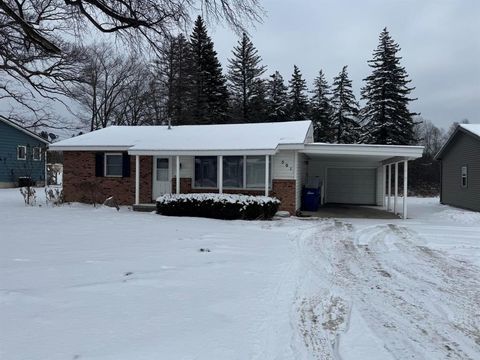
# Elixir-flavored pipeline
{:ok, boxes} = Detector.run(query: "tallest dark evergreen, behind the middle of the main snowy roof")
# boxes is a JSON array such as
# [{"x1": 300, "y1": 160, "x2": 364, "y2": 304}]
[{"x1": 189, "y1": 16, "x2": 228, "y2": 124}]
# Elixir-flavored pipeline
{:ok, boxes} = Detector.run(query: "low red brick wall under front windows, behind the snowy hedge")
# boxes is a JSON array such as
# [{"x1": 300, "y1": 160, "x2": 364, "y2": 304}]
[{"x1": 172, "y1": 178, "x2": 297, "y2": 215}]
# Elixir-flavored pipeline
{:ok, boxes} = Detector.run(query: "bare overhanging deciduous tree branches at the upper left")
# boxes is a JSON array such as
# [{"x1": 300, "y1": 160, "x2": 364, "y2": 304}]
[{"x1": 0, "y1": 0, "x2": 263, "y2": 126}]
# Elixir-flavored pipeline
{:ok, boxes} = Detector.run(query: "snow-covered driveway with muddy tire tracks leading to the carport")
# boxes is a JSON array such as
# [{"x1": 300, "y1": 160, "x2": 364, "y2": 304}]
[{"x1": 292, "y1": 220, "x2": 480, "y2": 359}]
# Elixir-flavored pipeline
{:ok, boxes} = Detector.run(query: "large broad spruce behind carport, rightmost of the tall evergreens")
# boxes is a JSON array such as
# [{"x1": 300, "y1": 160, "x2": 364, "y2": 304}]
[{"x1": 361, "y1": 28, "x2": 417, "y2": 145}]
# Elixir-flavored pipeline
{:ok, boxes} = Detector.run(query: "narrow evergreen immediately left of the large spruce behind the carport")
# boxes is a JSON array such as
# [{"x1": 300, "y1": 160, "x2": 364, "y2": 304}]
[{"x1": 330, "y1": 66, "x2": 360, "y2": 144}]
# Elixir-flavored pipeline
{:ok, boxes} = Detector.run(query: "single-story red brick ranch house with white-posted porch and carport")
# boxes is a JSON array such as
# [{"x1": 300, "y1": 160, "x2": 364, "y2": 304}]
[{"x1": 50, "y1": 121, "x2": 423, "y2": 216}]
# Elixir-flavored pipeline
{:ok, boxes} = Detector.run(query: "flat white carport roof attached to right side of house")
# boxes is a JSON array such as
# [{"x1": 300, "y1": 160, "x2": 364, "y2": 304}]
[{"x1": 300, "y1": 143, "x2": 423, "y2": 163}]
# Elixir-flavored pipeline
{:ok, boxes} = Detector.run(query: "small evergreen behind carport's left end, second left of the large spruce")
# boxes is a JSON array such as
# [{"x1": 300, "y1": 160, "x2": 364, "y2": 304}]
[{"x1": 310, "y1": 70, "x2": 334, "y2": 142}]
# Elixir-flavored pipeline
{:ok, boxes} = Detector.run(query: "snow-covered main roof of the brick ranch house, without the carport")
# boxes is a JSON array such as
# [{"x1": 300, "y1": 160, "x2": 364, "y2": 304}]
[{"x1": 50, "y1": 120, "x2": 311, "y2": 155}]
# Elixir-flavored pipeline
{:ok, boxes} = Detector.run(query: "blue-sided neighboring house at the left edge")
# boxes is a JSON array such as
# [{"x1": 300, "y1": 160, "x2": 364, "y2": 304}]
[{"x1": 0, "y1": 117, "x2": 49, "y2": 188}]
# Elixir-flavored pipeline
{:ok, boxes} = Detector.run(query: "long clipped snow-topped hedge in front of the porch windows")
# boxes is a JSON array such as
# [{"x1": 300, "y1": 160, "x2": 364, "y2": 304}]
[{"x1": 157, "y1": 194, "x2": 280, "y2": 220}]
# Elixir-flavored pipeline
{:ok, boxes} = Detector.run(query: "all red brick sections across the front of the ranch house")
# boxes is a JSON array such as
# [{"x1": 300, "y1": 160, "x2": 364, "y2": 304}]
[{"x1": 63, "y1": 151, "x2": 297, "y2": 215}]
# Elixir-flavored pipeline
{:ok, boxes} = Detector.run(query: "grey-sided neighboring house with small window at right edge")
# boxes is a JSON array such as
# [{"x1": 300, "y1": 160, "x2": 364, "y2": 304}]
[{"x1": 435, "y1": 124, "x2": 480, "y2": 211}]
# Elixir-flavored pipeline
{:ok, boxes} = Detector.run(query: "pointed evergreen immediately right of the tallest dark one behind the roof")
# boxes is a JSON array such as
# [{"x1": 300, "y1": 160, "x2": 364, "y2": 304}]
[{"x1": 227, "y1": 33, "x2": 266, "y2": 122}]
